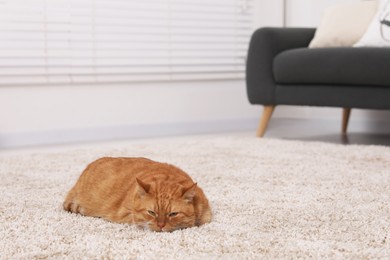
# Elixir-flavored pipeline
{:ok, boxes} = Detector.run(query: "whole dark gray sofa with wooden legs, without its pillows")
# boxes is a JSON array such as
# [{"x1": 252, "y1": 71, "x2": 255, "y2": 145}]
[{"x1": 246, "y1": 28, "x2": 390, "y2": 136}]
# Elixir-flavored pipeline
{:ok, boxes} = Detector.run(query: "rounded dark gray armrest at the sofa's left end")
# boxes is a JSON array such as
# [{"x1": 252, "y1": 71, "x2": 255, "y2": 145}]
[{"x1": 246, "y1": 27, "x2": 315, "y2": 105}]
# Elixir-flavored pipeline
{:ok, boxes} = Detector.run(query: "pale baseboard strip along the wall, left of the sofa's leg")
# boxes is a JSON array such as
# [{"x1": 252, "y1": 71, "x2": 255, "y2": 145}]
[{"x1": 0, "y1": 118, "x2": 258, "y2": 149}]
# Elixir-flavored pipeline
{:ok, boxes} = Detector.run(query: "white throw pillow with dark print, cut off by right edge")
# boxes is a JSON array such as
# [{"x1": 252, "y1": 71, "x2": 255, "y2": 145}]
[{"x1": 354, "y1": 0, "x2": 390, "y2": 47}]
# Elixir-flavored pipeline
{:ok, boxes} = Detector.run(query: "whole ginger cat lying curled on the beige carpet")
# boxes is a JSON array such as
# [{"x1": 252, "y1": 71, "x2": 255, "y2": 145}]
[{"x1": 63, "y1": 157, "x2": 212, "y2": 232}]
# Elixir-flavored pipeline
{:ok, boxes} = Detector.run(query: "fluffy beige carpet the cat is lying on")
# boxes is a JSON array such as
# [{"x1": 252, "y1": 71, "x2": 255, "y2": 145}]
[{"x1": 0, "y1": 136, "x2": 390, "y2": 259}]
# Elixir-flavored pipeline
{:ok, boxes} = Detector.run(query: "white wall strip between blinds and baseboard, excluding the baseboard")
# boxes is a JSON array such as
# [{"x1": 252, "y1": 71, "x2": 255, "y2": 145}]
[{"x1": 0, "y1": 80, "x2": 254, "y2": 132}]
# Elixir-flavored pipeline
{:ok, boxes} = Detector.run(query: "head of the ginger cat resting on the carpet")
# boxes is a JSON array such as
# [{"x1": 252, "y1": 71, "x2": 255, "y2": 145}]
[{"x1": 133, "y1": 179, "x2": 197, "y2": 232}]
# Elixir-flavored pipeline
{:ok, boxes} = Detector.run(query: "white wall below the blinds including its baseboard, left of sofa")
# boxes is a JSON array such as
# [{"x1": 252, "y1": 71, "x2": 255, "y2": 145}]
[{"x1": 0, "y1": 80, "x2": 260, "y2": 148}]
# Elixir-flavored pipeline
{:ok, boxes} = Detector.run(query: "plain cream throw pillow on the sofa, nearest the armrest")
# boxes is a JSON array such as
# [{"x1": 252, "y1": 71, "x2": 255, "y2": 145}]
[{"x1": 309, "y1": 1, "x2": 378, "y2": 48}]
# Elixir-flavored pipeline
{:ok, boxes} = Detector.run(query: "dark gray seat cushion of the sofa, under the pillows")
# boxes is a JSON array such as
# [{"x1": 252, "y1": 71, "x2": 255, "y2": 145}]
[{"x1": 273, "y1": 48, "x2": 390, "y2": 87}]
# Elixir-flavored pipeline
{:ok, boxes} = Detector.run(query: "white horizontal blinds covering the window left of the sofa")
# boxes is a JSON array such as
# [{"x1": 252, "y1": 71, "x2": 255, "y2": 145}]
[{"x1": 0, "y1": 0, "x2": 253, "y2": 86}]
